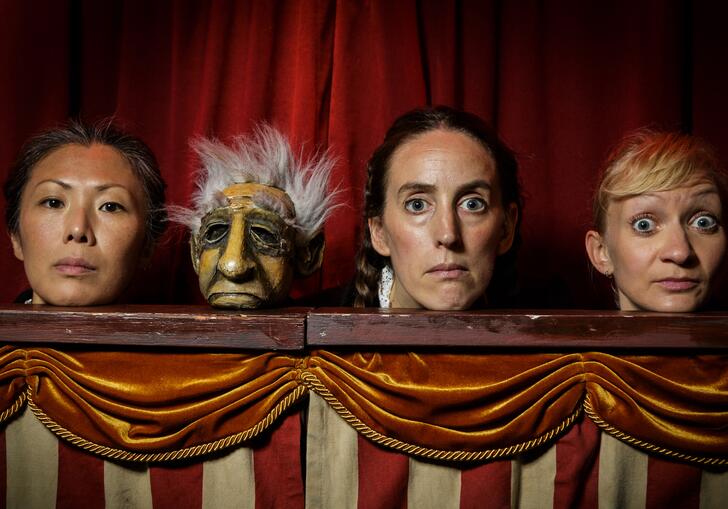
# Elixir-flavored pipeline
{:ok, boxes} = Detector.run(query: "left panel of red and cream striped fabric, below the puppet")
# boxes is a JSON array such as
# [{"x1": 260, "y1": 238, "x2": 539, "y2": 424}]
[{"x1": 0, "y1": 409, "x2": 304, "y2": 509}]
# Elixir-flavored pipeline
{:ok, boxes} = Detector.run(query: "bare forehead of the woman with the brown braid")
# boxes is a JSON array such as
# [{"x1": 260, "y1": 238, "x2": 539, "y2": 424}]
[{"x1": 388, "y1": 129, "x2": 497, "y2": 192}]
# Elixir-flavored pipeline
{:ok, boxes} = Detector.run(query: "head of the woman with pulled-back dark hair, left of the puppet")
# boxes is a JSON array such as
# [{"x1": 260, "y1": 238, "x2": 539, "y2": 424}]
[{"x1": 4, "y1": 121, "x2": 166, "y2": 306}]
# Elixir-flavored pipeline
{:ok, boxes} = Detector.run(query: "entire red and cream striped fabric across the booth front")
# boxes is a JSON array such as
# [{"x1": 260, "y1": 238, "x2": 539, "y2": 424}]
[{"x1": 0, "y1": 394, "x2": 728, "y2": 509}]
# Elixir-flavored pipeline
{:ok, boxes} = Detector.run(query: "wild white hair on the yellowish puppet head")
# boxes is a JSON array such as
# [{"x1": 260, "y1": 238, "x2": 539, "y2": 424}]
[{"x1": 170, "y1": 125, "x2": 338, "y2": 242}]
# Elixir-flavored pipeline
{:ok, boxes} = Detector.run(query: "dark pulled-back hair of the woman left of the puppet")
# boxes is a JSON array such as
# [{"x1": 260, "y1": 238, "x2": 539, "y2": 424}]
[{"x1": 4, "y1": 120, "x2": 167, "y2": 247}]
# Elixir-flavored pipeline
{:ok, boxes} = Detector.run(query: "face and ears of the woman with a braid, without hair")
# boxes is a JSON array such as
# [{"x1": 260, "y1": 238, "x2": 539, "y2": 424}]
[{"x1": 369, "y1": 129, "x2": 518, "y2": 310}]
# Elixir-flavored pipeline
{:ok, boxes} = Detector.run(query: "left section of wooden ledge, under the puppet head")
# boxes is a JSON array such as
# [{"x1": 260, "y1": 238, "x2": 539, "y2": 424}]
[{"x1": 0, "y1": 304, "x2": 310, "y2": 350}]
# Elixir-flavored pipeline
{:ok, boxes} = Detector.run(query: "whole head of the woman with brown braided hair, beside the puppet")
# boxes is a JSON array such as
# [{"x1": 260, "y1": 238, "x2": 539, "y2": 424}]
[{"x1": 354, "y1": 106, "x2": 522, "y2": 310}]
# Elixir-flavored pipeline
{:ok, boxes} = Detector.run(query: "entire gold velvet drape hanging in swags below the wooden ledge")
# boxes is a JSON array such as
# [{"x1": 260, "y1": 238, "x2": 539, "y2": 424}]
[{"x1": 0, "y1": 346, "x2": 728, "y2": 464}]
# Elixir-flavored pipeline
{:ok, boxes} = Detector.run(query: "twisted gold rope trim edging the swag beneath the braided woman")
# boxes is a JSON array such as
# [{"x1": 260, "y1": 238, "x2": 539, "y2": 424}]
[{"x1": 301, "y1": 372, "x2": 581, "y2": 461}]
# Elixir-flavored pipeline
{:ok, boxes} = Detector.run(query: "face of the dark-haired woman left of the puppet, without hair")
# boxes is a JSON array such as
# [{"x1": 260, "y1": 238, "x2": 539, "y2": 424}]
[{"x1": 11, "y1": 144, "x2": 146, "y2": 306}]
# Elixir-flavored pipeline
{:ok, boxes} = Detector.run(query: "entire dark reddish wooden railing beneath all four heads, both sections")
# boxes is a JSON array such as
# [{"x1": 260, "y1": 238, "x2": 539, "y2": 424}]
[{"x1": 0, "y1": 305, "x2": 728, "y2": 352}]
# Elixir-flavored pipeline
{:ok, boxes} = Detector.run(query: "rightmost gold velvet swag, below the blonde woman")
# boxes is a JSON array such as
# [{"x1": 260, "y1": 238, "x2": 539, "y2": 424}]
[{"x1": 585, "y1": 353, "x2": 728, "y2": 458}]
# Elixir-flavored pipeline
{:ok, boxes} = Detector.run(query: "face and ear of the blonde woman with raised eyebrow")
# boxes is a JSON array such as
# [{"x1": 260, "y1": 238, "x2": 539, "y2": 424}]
[{"x1": 586, "y1": 176, "x2": 726, "y2": 312}]
